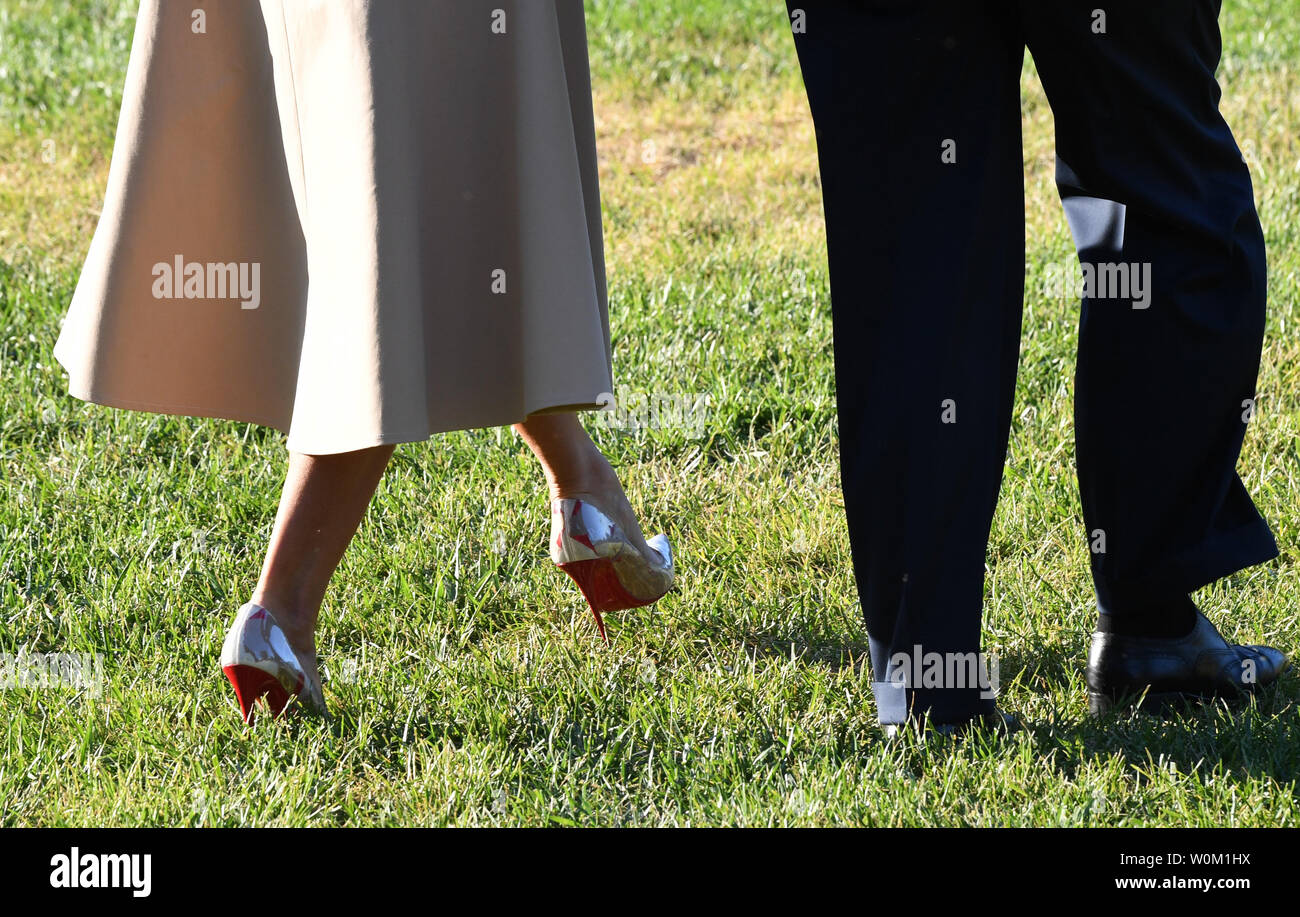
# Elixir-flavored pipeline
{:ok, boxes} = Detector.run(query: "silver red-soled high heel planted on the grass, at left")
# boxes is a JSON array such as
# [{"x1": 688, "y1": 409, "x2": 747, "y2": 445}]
[{"x1": 221, "y1": 602, "x2": 325, "y2": 726}]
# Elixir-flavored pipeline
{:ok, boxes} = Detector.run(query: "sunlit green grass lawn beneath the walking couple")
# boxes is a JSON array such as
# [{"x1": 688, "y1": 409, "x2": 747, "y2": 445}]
[{"x1": 0, "y1": 0, "x2": 1300, "y2": 826}]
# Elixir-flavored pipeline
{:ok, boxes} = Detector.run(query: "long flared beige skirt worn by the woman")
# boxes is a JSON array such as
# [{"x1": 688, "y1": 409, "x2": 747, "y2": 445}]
[{"x1": 55, "y1": 0, "x2": 612, "y2": 454}]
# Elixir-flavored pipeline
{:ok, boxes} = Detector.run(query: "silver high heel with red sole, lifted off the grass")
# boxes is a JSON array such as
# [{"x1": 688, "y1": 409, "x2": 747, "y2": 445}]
[{"x1": 551, "y1": 499, "x2": 673, "y2": 643}]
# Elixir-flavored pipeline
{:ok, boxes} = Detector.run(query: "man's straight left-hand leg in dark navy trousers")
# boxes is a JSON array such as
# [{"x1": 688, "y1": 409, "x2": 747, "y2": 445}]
[{"x1": 789, "y1": 0, "x2": 1024, "y2": 723}]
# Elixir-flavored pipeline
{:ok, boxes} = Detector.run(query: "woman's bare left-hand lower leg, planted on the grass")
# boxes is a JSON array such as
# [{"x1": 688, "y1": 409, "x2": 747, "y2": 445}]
[{"x1": 252, "y1": 446, "x2": 395, "y2": 688}]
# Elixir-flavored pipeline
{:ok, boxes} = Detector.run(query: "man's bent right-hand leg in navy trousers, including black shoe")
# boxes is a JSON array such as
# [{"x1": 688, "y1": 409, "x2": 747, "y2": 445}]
[{"x1": 1022, "y1": 0, "x2": 1286, "y2": 713}]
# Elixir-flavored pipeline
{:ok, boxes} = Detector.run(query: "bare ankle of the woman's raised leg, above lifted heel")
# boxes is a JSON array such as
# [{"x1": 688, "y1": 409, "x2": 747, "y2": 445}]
[{"x1": 515, "y1": 414, "x2": 650, "y2": 555}]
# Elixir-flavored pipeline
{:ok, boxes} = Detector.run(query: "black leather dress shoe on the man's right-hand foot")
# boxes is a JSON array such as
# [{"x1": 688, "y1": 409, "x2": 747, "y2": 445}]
[{"x1": 1088, "y1": 611, "x2": 1287, "y2": 715}]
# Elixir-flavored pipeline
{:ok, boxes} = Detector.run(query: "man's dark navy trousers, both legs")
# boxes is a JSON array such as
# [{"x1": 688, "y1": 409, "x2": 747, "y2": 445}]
[{"x1": 788, "y1": 0, "x2": 1277, "y2": 723}]
